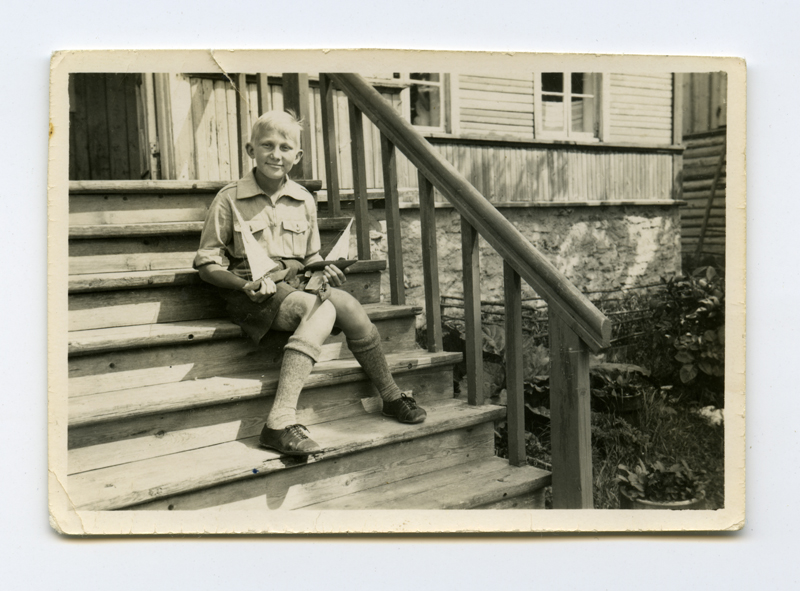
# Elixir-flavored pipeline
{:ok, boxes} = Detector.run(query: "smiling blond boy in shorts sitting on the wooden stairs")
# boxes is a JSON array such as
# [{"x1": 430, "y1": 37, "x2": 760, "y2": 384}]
[{"x1": 194, "y1": 111, "x2": 426, "y2": 456}]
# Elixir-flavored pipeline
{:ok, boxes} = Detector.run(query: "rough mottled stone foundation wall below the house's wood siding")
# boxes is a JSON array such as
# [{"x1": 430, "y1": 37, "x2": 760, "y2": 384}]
[{"x1": 360, "y1": 202, "x2": 681, "y2": 324}]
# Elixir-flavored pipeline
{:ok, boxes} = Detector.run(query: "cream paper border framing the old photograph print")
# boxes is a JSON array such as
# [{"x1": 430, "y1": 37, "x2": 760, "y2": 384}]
[{"x1": 48, "y1": 50, "x2": 746, "y2": 535}]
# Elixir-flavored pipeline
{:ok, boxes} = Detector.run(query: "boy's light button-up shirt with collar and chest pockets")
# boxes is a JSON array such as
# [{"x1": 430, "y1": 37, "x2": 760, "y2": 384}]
[{"x1": 194, "y1": 170, "x2": 320, "y2": 280}]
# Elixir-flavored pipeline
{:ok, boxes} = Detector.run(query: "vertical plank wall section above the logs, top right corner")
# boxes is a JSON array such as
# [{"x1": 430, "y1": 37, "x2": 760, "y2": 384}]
[{"x1": 682, "y1": 72, "x2": 728, "y2": 135}]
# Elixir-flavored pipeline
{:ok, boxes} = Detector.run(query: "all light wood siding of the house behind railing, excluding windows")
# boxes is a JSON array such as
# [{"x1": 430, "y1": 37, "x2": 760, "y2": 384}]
[{"x1": 87, "y1": 74, "x2": 672, "y2": 203}]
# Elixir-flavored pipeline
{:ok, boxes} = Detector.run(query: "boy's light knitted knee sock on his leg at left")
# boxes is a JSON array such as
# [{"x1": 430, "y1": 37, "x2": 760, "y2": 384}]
[{"x1": 267, "y1": 336, "x2": 321, "y2": 429}]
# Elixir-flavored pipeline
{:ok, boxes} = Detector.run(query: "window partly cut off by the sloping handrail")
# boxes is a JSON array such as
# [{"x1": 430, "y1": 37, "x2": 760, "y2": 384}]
[{"x1": 394, "y1": 72, "x2": 448, "y2": 131}]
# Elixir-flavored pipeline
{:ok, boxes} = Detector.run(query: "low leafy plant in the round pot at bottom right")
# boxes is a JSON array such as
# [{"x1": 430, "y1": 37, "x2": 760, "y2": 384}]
[{"x1": 617, "y1": 459, "x2": 703, "y2": 503}]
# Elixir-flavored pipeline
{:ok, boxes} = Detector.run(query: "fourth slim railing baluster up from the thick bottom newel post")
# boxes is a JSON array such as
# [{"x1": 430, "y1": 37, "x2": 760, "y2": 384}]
[{"x1": 381, "y1": 133, "x2": 406, "y2": 305}]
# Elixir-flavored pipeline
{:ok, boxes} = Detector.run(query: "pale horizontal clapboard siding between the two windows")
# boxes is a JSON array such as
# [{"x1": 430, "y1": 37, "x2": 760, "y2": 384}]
[{"x1": 453, "y1": 74, "x2": 533, "y2": 140}]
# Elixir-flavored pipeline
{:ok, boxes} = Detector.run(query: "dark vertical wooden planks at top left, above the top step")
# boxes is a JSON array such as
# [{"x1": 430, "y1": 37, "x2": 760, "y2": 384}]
[{"x1": 69, "y1": 74, "x2": 148, "y2": 180}]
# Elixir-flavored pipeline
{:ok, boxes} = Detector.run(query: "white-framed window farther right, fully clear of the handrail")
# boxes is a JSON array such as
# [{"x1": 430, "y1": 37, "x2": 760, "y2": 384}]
[{"x1": 534, "y1": 72, "x2": 601, "y2": 141}]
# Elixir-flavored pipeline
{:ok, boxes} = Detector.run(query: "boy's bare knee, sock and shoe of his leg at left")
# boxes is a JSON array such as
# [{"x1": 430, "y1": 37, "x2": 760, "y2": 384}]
[{"x1": 261, "y1": 292, "x2": 336, "y2": 455}]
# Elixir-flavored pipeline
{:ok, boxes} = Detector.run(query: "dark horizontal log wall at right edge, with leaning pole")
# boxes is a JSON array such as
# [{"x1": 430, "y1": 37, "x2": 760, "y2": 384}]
[{"x1": 681, "y1": 129, "x2": 725, "y2": 255}]
